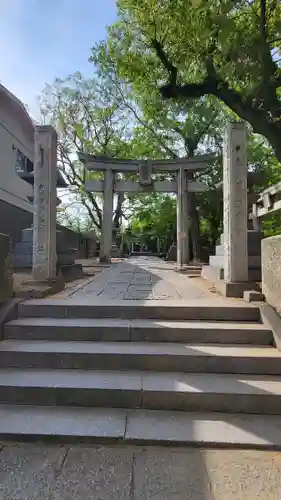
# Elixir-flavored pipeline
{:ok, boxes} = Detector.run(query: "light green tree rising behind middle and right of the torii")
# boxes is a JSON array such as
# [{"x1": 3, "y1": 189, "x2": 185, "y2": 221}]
[{"x1": 91, "y1": 38, "x2": 230, "y2": 259}]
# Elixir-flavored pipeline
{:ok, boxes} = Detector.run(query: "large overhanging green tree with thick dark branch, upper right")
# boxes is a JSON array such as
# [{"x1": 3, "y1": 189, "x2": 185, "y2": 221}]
[{"x1": 104, "y1": 0, "x2": 281, "y2": 160}]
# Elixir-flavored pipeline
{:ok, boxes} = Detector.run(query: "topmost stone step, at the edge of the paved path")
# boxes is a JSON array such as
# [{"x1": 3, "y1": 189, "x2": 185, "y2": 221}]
[{"x1": 18, "y1": 298, "x2": 260, "y2": 322}]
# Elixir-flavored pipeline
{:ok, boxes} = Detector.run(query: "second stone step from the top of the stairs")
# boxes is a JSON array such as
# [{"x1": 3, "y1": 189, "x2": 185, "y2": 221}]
[{"x1": 4, "y1": 317, "x2": 273, "y2": 345}]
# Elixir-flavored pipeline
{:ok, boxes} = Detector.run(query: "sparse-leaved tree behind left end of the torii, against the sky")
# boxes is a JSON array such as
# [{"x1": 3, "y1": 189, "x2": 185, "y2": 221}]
[{"x1": 40, "y1": 73, "x2": 131, "y2": 231}]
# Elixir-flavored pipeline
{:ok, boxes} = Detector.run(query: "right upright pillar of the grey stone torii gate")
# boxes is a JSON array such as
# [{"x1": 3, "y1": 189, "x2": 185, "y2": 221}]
[{"x1": 177, "y1": 167, "x2": 189, "y2": 267}]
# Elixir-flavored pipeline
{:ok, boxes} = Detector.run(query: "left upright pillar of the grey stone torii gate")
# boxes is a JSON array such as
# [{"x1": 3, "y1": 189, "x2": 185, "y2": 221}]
[{"x1": 100, "y1": 168, "x2": 114, "y2": 262}]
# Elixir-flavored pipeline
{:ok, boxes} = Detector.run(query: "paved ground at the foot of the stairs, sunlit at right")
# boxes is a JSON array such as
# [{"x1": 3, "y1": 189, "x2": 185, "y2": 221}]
[{"x1": 0, "y1": 443, "x2": 281, "y2": 500}]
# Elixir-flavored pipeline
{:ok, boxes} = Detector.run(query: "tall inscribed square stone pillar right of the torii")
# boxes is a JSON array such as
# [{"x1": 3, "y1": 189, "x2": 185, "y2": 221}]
[{"x1": 223, "y1": 122, "x2": 248, "y2": 296}]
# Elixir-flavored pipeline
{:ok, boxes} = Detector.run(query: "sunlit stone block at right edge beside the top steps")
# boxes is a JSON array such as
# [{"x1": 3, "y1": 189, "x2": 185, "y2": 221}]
[{"x1": 261, "y1": 235, "x2": 281, "y2": 314}]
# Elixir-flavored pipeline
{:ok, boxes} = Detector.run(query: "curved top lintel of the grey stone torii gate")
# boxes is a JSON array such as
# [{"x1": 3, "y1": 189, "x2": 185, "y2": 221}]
[{"x1": 78, "y1": 153, "x2": 215, "y2": 172}]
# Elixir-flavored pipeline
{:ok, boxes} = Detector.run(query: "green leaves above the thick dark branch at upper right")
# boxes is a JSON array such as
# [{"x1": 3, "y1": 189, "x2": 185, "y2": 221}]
[{"x1": 104, "y1": 0, "x2": 281, "y2": 94}]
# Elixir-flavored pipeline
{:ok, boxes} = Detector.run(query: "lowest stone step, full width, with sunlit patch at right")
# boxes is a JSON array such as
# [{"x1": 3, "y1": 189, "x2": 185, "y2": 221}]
[{"x1": 0, "y1": 405, "x2": 281, "y2": 450}]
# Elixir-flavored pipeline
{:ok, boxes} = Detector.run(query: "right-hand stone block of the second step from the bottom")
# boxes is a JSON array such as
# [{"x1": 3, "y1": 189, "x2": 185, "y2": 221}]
[{"x1": 141, "y1": 373, "x2": 281, "y2": 415}]
